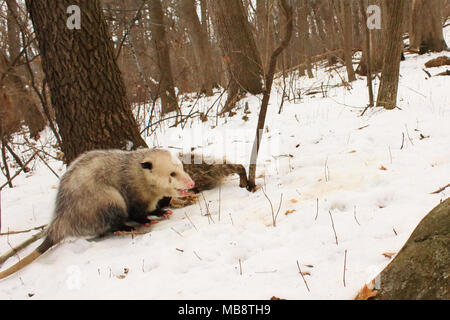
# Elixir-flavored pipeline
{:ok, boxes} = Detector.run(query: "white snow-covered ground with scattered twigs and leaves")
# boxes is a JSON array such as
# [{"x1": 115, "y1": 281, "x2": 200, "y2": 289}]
[{"x1": 0, "y1": 29, "x2": 450, "y2": 299}]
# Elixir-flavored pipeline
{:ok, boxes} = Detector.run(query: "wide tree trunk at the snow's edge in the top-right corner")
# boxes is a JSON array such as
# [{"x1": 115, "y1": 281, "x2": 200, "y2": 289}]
[{"x1": 410, "y1": 0, "x2": 447, "y2": 54}]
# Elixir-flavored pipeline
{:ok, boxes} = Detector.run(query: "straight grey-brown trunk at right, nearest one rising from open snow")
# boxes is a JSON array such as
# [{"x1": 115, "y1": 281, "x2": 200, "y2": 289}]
[{"x1": 377, "y1": 0, "x2": 406, "y2": 110}]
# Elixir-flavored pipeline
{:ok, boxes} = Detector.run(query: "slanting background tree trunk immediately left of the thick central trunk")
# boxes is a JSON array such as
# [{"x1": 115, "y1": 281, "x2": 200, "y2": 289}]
[{"x1": 177, "y1": 0, "x2": 217, "y2": 96}]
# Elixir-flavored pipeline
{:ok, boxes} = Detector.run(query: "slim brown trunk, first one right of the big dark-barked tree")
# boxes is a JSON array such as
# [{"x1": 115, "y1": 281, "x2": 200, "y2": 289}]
[{"x1": 149, "y1": 0, "x2": 178, "y2": 115}]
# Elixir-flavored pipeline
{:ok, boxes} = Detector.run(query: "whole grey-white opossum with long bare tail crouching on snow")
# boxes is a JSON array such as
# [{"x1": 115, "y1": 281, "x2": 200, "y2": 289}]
[{"x1": 0, "y1": 149, "x2": 195, "y2": 279}]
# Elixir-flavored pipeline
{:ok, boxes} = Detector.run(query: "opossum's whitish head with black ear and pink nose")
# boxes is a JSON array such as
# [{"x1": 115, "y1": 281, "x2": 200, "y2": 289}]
[{"x1": 141, "y1": 150, "x2": 195, "y2": 197}]
